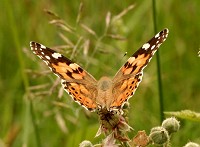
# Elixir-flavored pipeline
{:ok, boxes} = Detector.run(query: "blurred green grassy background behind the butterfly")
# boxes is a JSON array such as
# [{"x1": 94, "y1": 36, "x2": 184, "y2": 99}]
[{"x1": 0, "y1": 0, "x2": 200, "y2": 147}]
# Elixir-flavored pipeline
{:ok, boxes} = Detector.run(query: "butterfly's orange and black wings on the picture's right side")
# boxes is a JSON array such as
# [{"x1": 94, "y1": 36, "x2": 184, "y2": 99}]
[{"x1": 110, "y1": 29, "x2": 169, "y2": 108}]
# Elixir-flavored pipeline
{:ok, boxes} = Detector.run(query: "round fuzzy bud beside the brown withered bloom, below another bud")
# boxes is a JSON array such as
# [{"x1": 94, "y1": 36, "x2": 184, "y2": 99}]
[{"x1": 149, "y1": 127, "x2": 169, "y2": 145}]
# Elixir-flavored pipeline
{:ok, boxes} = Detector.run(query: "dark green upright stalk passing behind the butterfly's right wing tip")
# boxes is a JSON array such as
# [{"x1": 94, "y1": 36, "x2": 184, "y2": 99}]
[{"x1": 152, "y1": 0, "x2": 164, "y2": 123}]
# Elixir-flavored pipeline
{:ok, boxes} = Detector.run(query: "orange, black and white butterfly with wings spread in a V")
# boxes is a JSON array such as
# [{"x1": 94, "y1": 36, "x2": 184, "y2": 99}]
[{"x1": 30, "y1": 28, "x2": 169, "y2": 111}]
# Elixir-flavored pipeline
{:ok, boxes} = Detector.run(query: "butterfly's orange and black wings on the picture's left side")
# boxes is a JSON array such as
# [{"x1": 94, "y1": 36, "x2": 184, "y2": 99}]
[{"x1": 30, "y1": 42, "x2": 97, "y2": 111}]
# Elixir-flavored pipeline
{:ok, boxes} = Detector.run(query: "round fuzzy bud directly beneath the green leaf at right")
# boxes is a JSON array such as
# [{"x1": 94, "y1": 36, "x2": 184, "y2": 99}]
[{"x1": 162, "y1": 117, "x2": 180, "y2": 134}]
